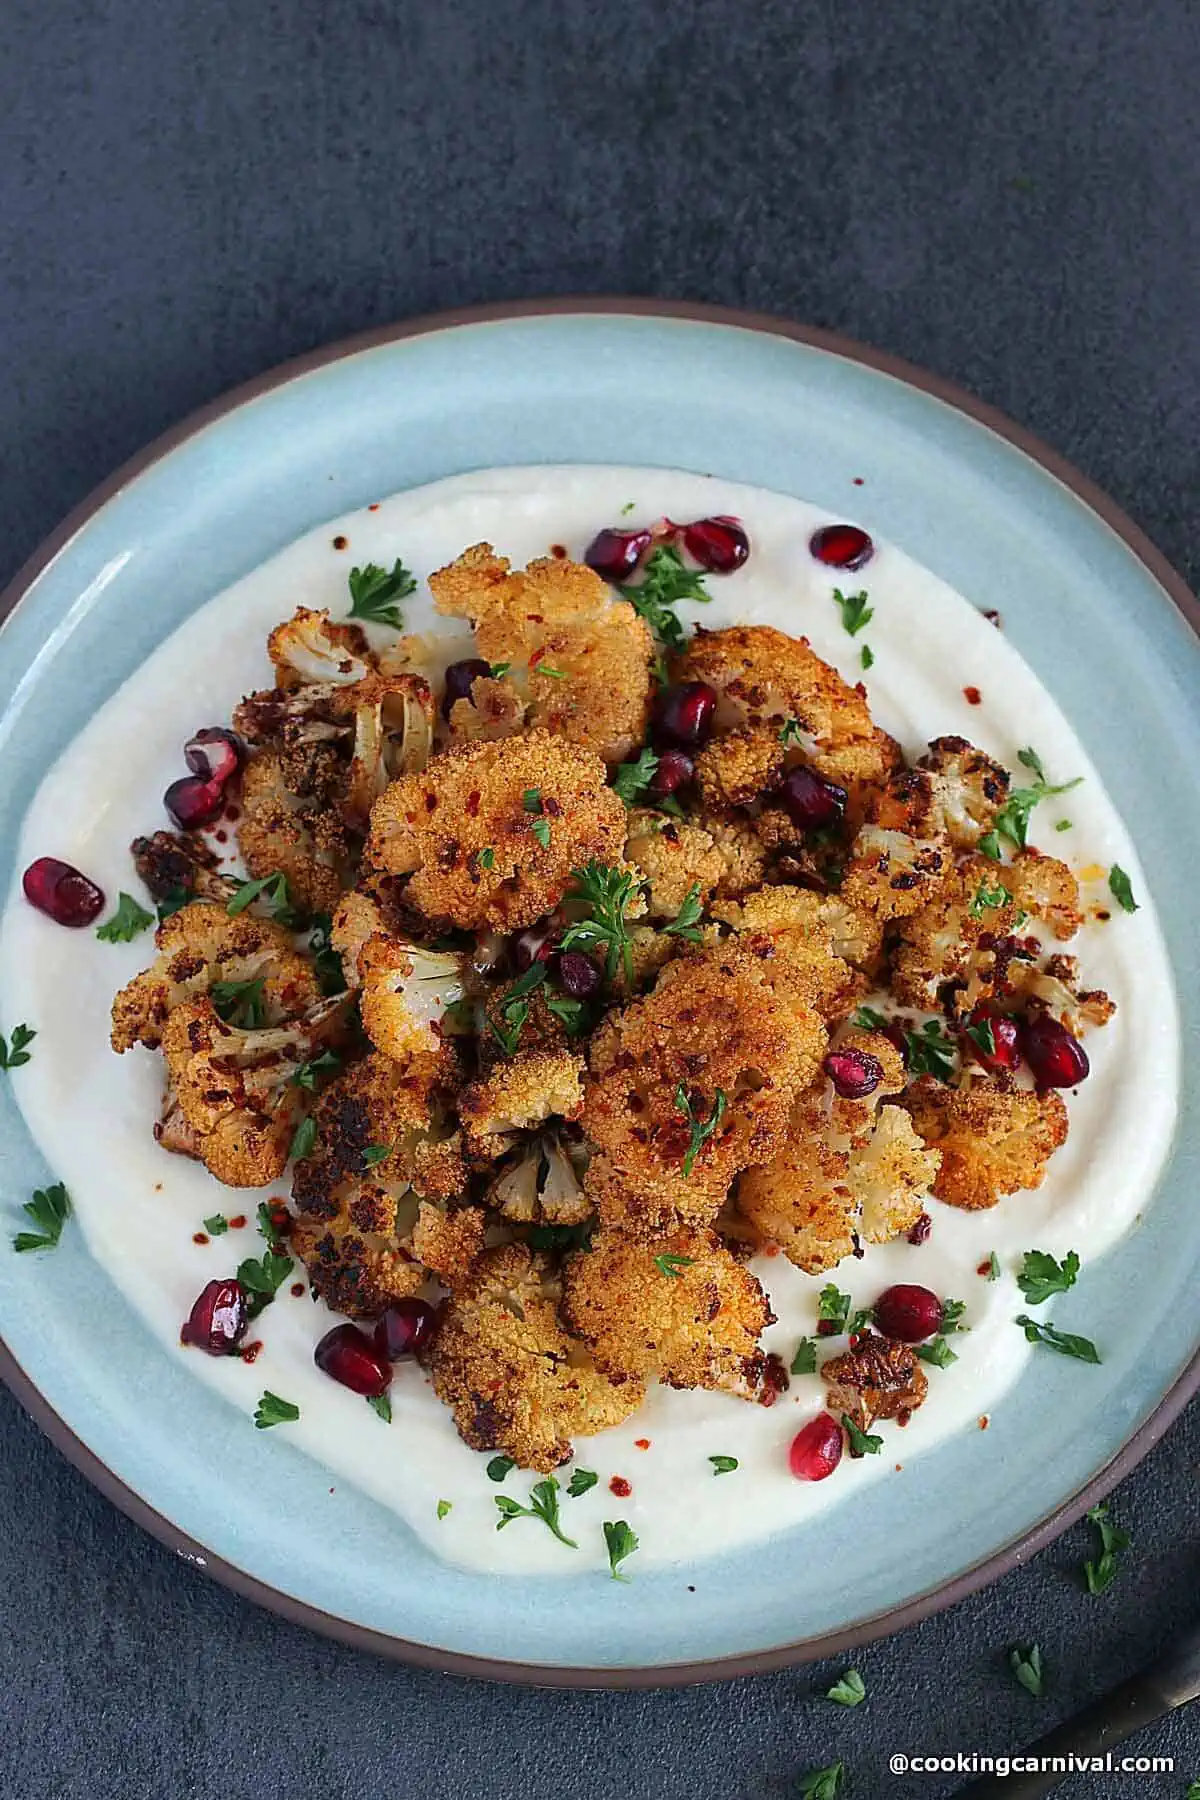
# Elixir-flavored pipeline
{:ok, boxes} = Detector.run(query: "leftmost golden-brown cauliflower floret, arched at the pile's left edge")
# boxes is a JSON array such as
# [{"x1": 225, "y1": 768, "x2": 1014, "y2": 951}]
[{"x1": 112, "y1": 900, "x2": 320, "y2": 1051}]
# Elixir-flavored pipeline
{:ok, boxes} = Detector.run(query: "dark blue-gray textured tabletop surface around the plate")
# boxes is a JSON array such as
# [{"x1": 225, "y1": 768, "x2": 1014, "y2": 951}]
[{"x1": 0, "y1": 0, "x2": 1200, "y2": 1800}]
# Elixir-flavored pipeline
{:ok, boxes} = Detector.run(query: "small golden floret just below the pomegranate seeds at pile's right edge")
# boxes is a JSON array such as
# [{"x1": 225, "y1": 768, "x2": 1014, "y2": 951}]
[{"x1": 903, "y1": 1075, "x2": 1067, "y2": 1211}]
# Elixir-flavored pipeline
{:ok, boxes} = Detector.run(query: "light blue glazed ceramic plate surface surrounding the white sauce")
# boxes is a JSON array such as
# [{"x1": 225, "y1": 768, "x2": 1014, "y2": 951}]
[{"x1": 0, "y1": 302, "x2": 1200, "y2": 1683}]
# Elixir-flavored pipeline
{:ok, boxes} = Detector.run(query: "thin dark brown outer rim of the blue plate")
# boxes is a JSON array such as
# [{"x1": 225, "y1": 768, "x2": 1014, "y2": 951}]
[{"x1": 0, "y1": 295, "x2": 1200, "y2": 1690}]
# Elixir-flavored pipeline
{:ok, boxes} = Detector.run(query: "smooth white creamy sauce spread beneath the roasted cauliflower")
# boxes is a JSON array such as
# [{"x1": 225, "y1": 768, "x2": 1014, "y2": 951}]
[{"x1": 0, "y1": 468, "x2": 1178, "y2": 1575}]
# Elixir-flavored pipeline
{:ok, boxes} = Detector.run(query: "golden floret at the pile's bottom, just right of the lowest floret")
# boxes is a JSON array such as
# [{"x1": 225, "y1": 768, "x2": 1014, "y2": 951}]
[{"x1": 563, "y1": 1226, "x2": 774, "y2": 1400}]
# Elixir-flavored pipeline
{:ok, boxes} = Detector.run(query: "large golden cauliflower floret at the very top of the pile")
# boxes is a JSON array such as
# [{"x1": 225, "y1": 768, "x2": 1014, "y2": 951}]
[{"x1": 430, "y1": 544, "x2": 655, "y2": 763}]
